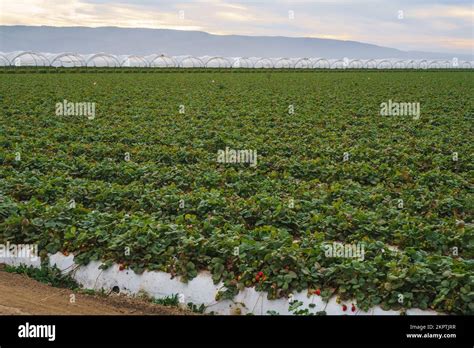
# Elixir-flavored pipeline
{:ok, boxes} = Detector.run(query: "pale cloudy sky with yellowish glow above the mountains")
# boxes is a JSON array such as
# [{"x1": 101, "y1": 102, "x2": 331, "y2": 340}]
[{"x1": 0, "y1": 0, "x2": 474, "y2": 54}]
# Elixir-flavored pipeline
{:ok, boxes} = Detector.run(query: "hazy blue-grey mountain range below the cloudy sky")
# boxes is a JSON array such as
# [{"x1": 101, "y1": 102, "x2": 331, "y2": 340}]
[{"x1": 0, "y1": 26, "x2": 473, "y2": 60}]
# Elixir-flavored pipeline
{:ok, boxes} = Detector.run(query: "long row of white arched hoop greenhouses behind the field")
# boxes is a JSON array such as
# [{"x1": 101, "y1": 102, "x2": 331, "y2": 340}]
[{"x1": 0, "y1": 51, "x2": 474, "y2": 69}]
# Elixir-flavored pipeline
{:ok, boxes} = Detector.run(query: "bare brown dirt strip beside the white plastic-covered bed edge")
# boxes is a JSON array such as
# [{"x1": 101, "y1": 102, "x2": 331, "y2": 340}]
[{"x1": 0, "y1": 270, "x2": 193, "y2": 315}]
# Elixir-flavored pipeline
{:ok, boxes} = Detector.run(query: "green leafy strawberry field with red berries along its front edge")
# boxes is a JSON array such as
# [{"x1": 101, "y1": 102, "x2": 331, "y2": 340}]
[{"x1": 0, "y1": 69, "x2": 474, "y2": 314}]
